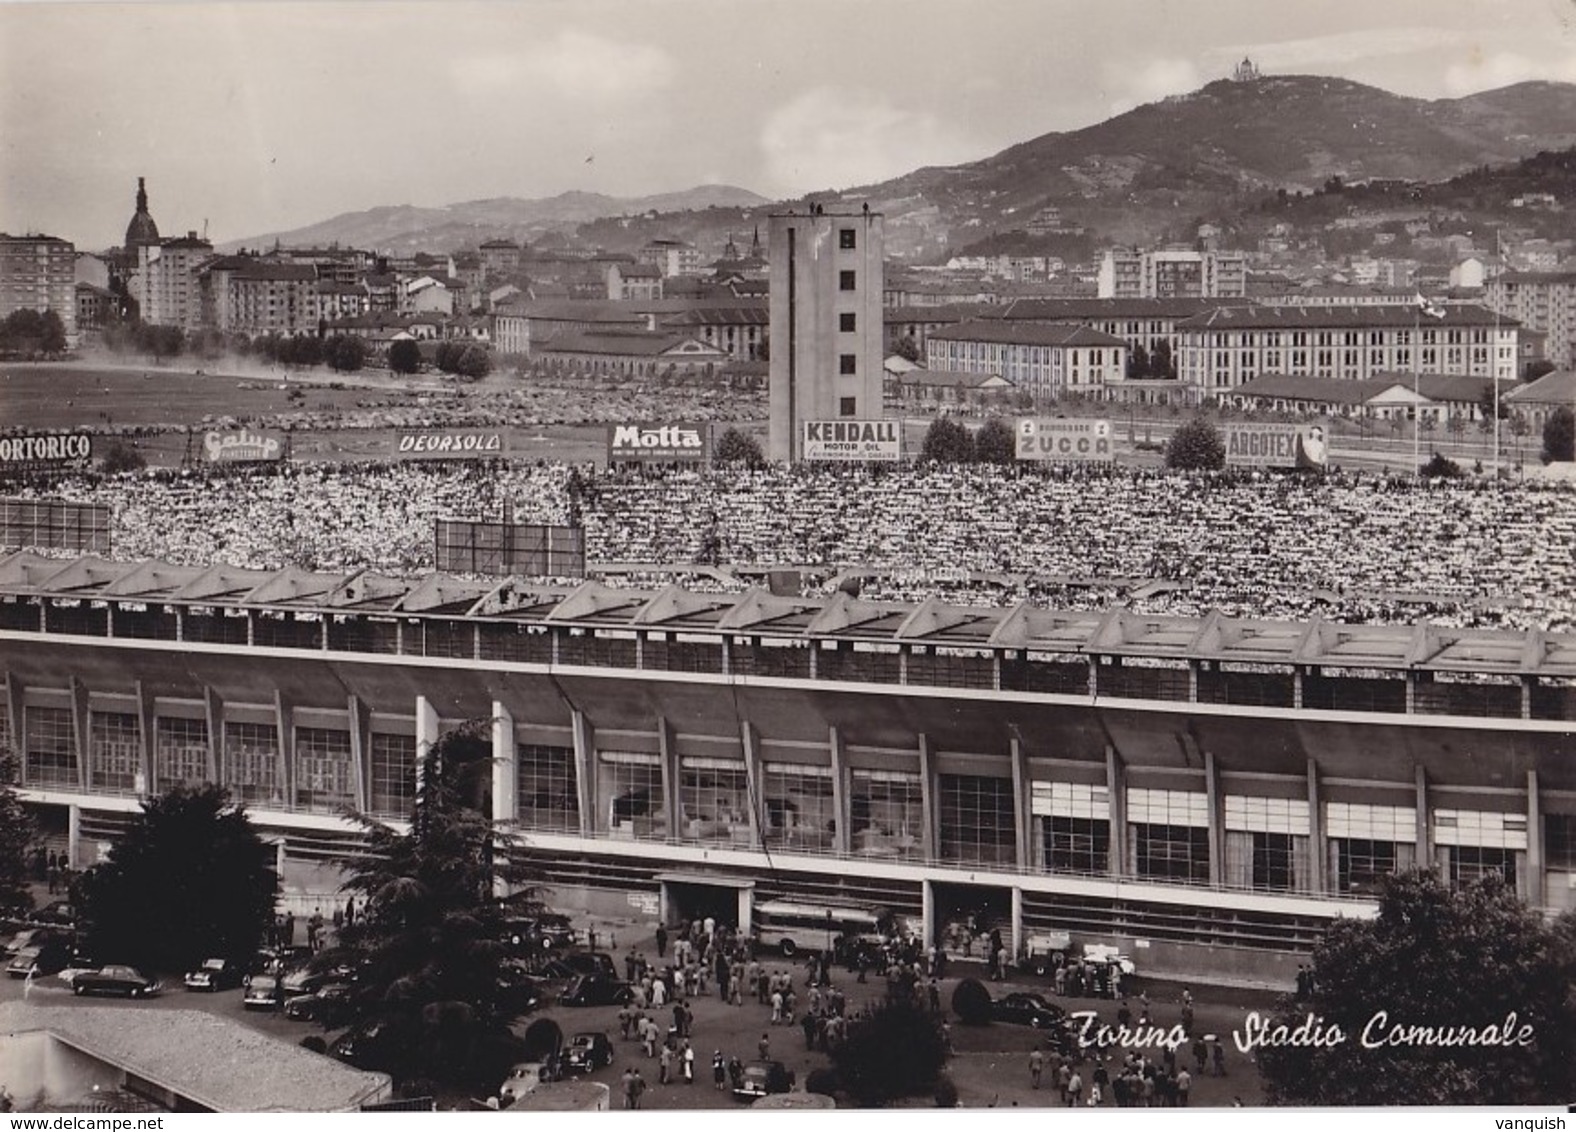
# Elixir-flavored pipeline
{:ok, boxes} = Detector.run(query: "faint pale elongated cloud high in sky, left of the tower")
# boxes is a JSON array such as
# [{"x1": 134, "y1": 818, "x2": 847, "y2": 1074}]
[{"x1": 452, "y1": 28, "x2": 679, "y2": 102}]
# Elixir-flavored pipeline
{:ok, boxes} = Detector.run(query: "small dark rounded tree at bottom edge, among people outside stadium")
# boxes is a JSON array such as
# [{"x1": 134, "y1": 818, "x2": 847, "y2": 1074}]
[{"x1": 832, "y1": 998, "x2": 947, "y2": 1108}]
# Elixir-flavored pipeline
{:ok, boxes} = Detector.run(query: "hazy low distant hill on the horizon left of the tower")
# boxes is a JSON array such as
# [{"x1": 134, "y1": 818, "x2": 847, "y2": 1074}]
[{"x1": 219, "y1": 184, "x2": 768, "y2": 252}]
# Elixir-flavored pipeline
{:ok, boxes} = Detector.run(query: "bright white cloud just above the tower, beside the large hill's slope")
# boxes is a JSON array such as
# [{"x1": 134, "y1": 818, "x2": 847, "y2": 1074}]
[{"x1": 760, "y1": 87, "x2": 979, "y2": 192}]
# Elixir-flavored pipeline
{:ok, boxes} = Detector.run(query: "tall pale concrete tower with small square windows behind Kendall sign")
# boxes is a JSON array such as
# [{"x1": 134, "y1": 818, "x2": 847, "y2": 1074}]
[{"x1": 766, "y1": 205, "x2": 883, "y2": 460}]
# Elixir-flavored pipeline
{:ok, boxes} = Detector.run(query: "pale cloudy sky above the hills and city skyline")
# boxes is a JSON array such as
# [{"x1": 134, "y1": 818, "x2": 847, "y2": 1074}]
[{"x1": 9, "y1": 0, "x2": 1576, "y2": 249}]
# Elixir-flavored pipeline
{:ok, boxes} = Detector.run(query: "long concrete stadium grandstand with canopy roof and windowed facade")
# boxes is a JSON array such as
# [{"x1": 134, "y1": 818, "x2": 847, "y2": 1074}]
[{"x1": 0, "y1": 553, "x2": 1576, "y2": 974}]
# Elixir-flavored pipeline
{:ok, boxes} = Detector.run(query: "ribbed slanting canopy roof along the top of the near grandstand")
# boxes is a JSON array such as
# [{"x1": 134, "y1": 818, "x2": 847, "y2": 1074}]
[{"x1": 0, "y1": 550, "x2": 1576, "y2": 676}]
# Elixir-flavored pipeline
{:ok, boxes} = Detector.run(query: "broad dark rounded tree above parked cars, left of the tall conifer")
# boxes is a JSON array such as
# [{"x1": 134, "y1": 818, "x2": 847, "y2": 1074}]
[{"x1": 79, "y1": 784, "x2": 279, "y2": 971}]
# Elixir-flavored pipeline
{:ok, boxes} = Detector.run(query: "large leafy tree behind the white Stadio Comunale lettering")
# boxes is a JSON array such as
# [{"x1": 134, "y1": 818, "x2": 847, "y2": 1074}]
[{"x1": 1239, "y1": 870, "x2": 1576, "y2": 1105}]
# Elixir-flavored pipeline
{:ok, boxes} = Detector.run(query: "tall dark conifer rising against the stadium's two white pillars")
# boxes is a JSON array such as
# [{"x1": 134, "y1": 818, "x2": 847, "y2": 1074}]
[{"x1": 322, "y1": 722, "x2": 539, "y2": 1088}]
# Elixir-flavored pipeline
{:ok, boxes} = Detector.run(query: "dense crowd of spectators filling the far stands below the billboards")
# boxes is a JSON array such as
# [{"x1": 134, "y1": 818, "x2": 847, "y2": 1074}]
[{"x1": 6, "y1": 464, "x2": 1576, "y2": 631}]
